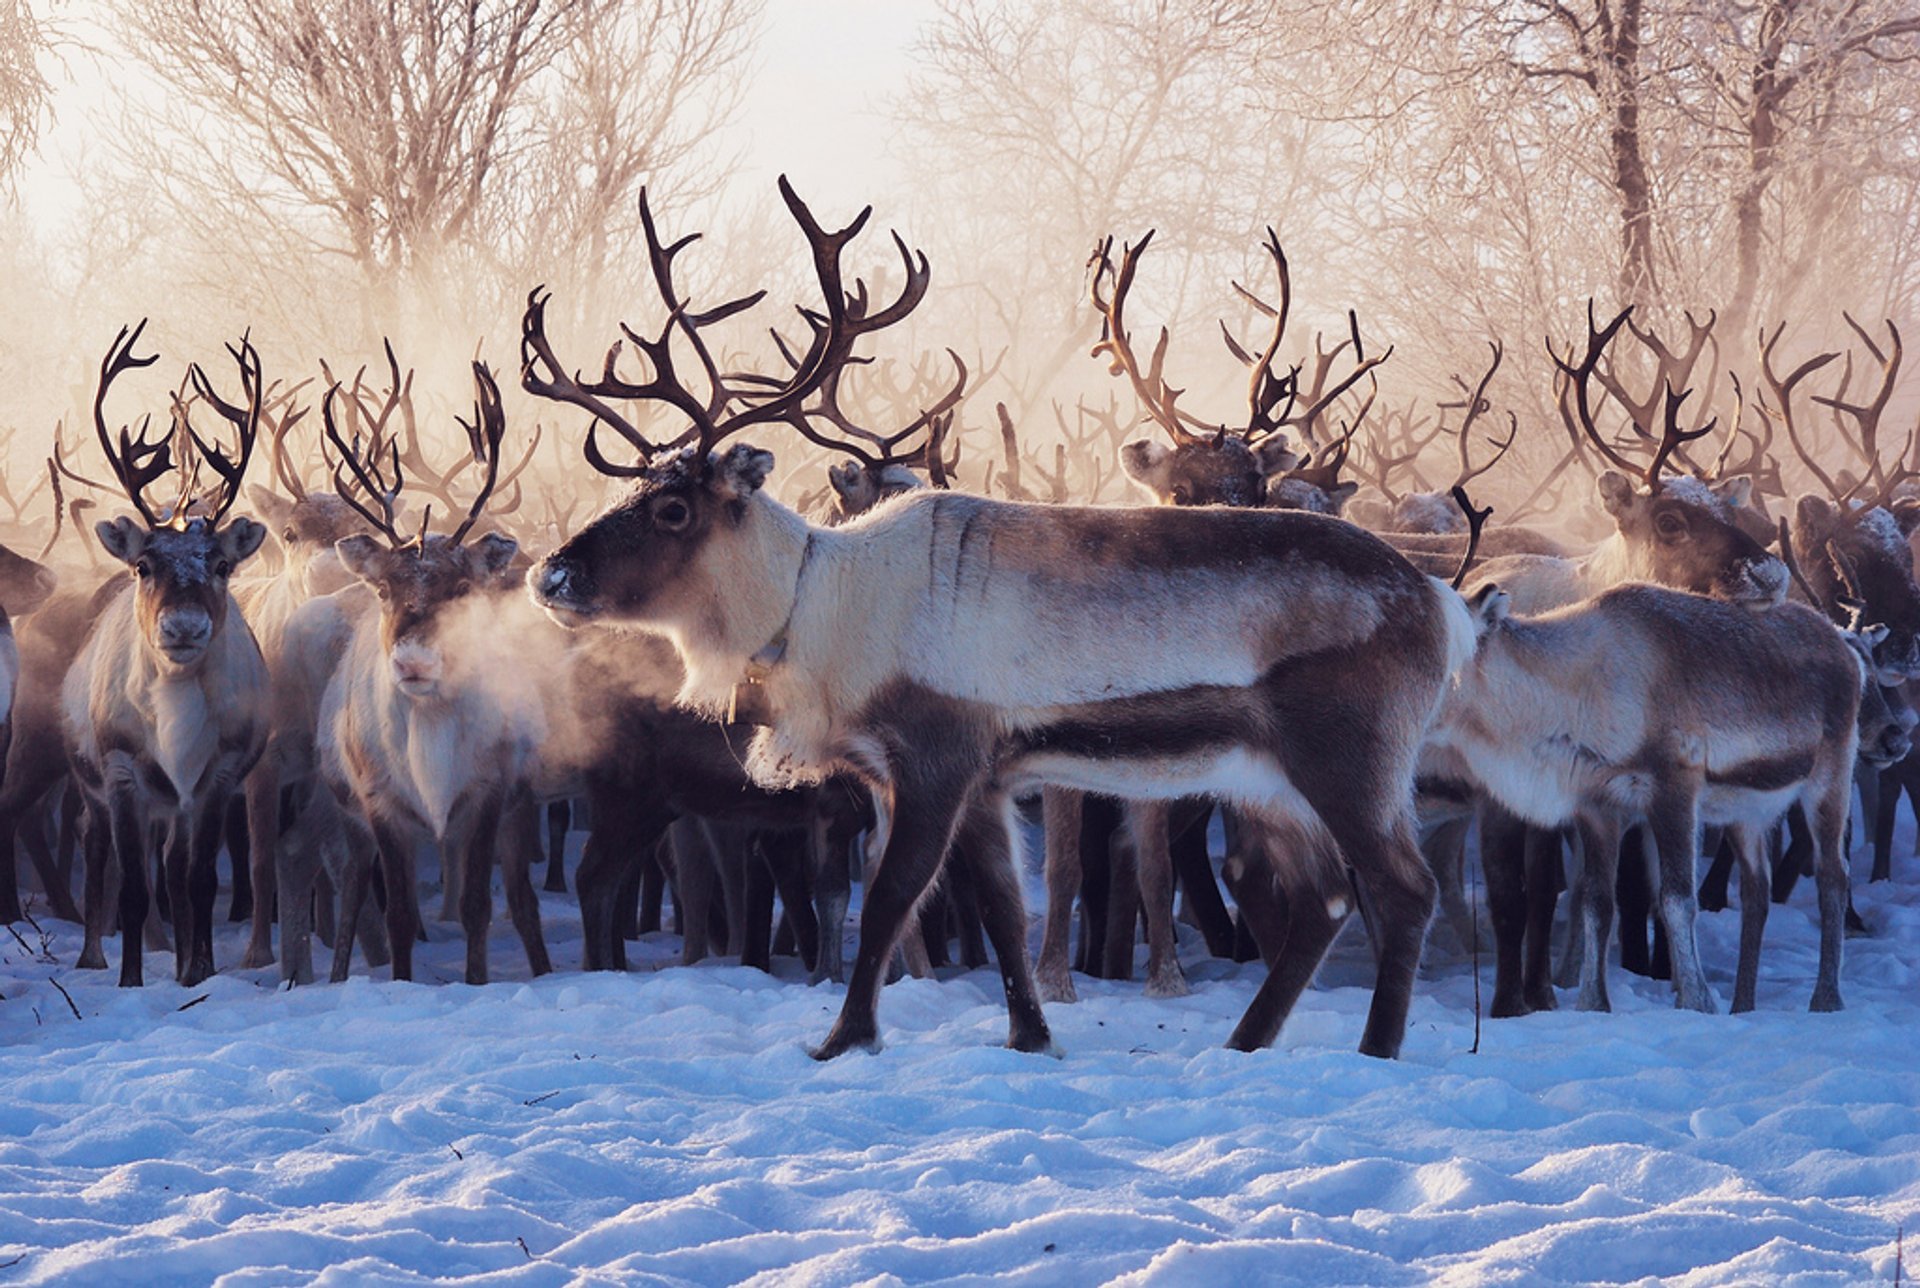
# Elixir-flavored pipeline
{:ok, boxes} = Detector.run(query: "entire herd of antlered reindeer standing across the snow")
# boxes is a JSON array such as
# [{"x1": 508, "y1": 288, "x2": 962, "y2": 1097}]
[{"x1": 0, "y1": 180, "x2": 1920, "y2": 1058}]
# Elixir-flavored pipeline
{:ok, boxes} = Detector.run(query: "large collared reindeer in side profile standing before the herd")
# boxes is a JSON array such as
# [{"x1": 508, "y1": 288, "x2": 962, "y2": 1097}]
[{"x1": 528, "y1": 180, "x2": 1473, "y2": 1058}]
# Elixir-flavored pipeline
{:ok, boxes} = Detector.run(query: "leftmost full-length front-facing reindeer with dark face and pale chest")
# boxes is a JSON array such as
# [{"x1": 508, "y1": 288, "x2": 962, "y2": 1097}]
[{"x1": 61, "y1": 322, "x2": 267, "y2": 989}]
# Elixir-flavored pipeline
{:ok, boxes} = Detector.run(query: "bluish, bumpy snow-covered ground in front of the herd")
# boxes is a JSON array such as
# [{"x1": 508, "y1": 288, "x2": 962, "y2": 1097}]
[{"x1": 0, "y1": 833, "x2": 1920, "y2": 1284}]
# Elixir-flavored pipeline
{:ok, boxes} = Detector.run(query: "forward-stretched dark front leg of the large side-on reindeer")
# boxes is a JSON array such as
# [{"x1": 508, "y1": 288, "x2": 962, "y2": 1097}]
[{"x1": 812, "y1": 764, "x2": 979, "y2": 1060}]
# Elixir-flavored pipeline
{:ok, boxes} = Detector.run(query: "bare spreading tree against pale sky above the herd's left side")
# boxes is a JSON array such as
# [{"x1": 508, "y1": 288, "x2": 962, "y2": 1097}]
[{"x1": 118, "y1": 0, "x2": 758, "y2": 345}]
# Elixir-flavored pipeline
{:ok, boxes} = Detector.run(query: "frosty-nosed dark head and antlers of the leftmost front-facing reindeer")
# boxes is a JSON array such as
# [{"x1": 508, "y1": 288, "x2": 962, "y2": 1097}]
[{"x1": 94, "y1": 321, "x2": 267, "y2": 670}]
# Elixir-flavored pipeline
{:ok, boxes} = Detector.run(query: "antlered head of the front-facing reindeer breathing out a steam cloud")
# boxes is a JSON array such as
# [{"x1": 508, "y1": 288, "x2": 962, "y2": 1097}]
[{"x1": 328, "y1": 363, "x2": 520, "y2": 701}]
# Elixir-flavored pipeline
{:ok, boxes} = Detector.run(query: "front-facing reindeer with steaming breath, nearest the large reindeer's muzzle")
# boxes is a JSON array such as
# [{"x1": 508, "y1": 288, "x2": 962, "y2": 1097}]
[{"x1": 319, "y1": 363, "x2": 549, "y2": 983}]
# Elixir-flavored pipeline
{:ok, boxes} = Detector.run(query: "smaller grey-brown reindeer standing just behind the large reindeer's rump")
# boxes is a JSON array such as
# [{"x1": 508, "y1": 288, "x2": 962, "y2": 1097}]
[{"x1": 1428, "y1": 585, "x2": 1905, "y2": 1012}]
